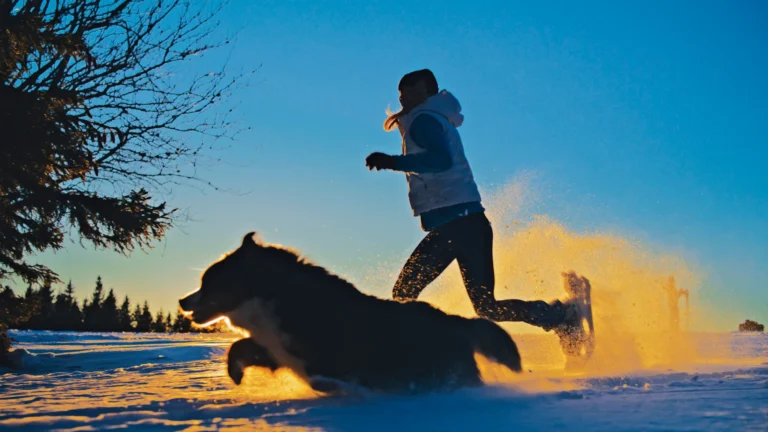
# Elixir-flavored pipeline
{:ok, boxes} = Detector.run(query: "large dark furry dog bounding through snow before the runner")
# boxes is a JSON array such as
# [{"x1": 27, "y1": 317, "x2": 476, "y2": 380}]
[{"x1": 179, "y1": 233, "x2": 521, "y2": 392}]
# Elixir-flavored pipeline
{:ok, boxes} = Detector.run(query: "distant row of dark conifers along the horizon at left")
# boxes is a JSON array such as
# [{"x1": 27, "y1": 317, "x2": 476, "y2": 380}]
[{"x1": 0, "y1": 277, "x2": 221, "y2": 333}]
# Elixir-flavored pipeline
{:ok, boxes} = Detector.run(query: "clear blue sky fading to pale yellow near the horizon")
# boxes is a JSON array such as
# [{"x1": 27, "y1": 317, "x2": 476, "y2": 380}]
[{"x1": 27, "y1": 0, "x2": 768, "y2": 326}]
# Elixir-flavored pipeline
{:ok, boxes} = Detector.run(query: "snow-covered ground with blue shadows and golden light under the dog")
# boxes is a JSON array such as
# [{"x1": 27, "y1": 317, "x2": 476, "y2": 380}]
[{"x1": 0, "y1": 332, "x2": 768, "y2": 432}]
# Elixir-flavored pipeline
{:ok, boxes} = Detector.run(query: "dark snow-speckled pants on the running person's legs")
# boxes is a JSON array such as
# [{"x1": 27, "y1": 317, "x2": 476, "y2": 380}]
[{"x1": 392, "y1": 213, "x2": 564, "y2": 330}]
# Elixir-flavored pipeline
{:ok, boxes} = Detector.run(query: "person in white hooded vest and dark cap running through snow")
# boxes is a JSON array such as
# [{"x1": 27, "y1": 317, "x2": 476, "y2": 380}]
[{"x1": 365, "y1": 69, "x2": 580, "y2": 339}]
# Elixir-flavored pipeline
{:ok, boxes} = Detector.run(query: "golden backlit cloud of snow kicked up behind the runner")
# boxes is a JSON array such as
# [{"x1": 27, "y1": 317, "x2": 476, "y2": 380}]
[{"x1": 412, "y1": 174, "x2": 711, "y2": 373}]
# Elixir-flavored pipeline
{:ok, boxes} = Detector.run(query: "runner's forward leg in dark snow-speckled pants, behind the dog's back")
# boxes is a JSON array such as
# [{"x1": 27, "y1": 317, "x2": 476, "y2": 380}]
[{"x1": 392, "y1": 228, "x2": 456, "y2": 300}]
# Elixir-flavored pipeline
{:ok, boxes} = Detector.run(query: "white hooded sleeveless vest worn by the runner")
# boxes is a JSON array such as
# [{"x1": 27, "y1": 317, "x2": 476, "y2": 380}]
[{"x1": 397, "y1": 90, "x2": 481, "y2": 216}]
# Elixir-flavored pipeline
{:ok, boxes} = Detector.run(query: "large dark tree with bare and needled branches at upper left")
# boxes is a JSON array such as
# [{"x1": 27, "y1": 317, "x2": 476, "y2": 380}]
[{"x1": 0, "y1": 0, "x2": 242, "y2": 286}]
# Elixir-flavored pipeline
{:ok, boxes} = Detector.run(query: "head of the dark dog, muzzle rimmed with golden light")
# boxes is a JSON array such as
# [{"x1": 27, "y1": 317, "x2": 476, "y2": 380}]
[{"x1": 179, "y1": 232, "x2": 300, "y2": 324}]
